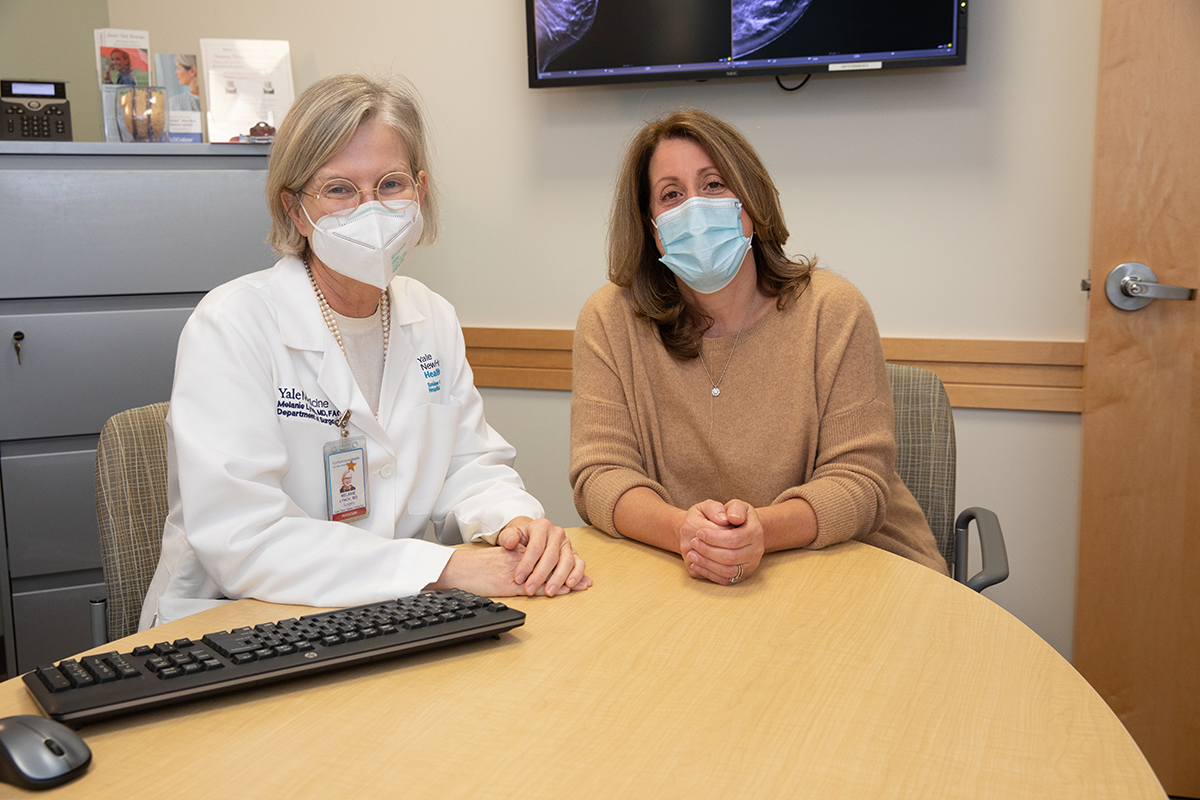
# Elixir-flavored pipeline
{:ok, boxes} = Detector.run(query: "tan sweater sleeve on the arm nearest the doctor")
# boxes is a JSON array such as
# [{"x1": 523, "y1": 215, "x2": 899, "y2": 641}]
[{"x1": 570, "y1": 289, "x2": 671, "y2": 537}]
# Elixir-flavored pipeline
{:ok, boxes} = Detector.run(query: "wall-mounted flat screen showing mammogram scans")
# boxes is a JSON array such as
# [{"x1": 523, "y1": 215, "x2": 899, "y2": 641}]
[{"x1": 526, "y1": 0, "x2": 967, "y2": 88}]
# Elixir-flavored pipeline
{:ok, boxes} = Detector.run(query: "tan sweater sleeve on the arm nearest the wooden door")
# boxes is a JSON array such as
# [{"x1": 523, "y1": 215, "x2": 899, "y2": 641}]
[{"x1": 775, "y1": 283, "x2": 895, "y2": 549}]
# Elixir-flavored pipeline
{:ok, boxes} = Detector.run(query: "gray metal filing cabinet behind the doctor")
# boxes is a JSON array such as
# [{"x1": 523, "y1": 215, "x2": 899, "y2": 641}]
[{"x1": 0, "y1": 142, "x2": 275, "y2": 675}]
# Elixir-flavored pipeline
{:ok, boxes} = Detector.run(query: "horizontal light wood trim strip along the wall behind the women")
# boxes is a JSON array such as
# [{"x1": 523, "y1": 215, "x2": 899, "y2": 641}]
[{"x1": 462, "y1": 327, "x2": 1085, "y2": 413}]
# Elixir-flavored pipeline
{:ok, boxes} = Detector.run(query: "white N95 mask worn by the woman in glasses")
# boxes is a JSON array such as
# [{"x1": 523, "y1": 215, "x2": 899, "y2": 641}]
[{"x1": 300, "y1": 200, "x2": 425, "y2": 291}]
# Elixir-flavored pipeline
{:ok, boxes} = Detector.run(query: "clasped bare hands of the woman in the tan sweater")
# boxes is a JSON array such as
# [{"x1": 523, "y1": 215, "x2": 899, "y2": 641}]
[{"x1": 677, "y1": 500, "x2": 766, "y2": 585}]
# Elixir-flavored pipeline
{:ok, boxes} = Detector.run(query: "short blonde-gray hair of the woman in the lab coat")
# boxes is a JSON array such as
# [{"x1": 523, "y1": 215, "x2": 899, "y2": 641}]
[{"x1": 266, "y1": 74, "x2": 438, "y2": 255}]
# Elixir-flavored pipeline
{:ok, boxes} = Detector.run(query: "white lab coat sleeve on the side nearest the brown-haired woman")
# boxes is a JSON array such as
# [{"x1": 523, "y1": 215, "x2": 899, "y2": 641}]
[{"x1": 432, "y1": 303, "x2": 545, "y2": 545}]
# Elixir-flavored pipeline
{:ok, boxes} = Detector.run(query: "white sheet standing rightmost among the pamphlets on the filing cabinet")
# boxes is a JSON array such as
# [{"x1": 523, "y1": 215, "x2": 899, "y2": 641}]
[{"x1": 200, "y1": 38, "x2": 294, "y2": 142}]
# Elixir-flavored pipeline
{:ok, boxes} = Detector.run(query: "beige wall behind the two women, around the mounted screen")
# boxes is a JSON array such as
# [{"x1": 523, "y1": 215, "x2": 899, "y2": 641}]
[{"x1": 14, "y1": 0, "x2": 1099, "y2": 657}]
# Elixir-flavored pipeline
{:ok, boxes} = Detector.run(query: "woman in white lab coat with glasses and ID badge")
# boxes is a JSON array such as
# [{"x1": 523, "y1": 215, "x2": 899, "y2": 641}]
[{"x1": 140, "y1": 76, "x2": 590, "y2": 630}]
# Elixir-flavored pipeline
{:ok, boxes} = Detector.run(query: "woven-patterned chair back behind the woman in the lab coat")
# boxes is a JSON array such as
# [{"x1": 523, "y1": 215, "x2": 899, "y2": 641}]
[{"x1": 91, "y1": 403, "x2": 168, "y2": 645}]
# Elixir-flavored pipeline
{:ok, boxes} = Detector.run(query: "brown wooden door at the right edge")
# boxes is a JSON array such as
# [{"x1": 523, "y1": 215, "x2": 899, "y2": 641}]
[{"x1": 1075, "y1": 0, "x2": 1200, "y2": 798}]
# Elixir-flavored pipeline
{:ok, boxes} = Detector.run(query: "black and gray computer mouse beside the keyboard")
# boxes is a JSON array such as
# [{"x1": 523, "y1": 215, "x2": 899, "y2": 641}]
[{"x1": 0, "y1": 714, "x2": 91, "y2": 789}]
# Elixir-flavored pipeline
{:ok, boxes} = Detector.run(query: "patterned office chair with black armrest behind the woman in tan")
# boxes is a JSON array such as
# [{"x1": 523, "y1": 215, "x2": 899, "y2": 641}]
[{"x1": 887, "y1": 363, "x2": 1008, "y2": 591}]
